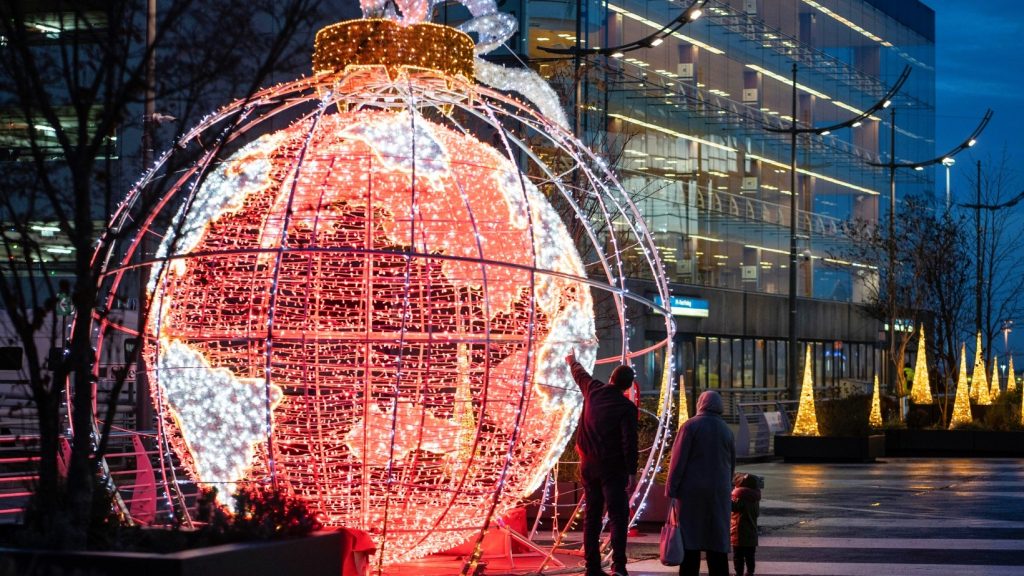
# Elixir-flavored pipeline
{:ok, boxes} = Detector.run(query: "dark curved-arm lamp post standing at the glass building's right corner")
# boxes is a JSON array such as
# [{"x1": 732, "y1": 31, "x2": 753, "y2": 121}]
[{"x1": 870, "y1": 109, "x2": 992, "y2": 396}]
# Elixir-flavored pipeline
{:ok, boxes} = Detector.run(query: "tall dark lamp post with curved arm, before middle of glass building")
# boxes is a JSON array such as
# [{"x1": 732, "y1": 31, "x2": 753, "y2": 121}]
[{"x1": 765, "y1": 63, "x2": 910, "y2": 398}]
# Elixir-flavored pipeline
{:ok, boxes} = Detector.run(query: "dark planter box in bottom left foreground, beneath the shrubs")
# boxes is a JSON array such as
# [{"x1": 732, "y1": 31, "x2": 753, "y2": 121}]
[{"x1": 0, "y1": 532, "x2": 344, "y2": 576}]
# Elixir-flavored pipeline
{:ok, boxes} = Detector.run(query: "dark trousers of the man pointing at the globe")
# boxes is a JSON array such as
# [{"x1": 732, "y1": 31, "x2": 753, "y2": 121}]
[{"x1": 580, "y1": 461, "x2": 630, "y2": 574}]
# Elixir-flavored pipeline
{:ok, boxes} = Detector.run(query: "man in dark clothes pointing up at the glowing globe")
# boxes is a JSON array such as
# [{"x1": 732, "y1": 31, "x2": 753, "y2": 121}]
[{"x1": 565, "y1": 354, "x2": 639, "y2": 576}]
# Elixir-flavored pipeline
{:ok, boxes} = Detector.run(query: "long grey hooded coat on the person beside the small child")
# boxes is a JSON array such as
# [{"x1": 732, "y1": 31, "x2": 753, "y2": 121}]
[{"x1": 665, "y1": 390, "x2": 736, "y2": 552}]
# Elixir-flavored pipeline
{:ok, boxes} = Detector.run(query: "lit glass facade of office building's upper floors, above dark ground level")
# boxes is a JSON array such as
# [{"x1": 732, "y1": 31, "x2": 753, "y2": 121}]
[{"x1": 524, "y1": 0, "x2": 935, "y2": 301}]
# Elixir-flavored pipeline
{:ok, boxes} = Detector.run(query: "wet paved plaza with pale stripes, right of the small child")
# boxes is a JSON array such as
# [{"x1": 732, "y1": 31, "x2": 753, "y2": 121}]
[{"x1": 614, "y1": 458, "x2": 1024, "y2": 576}]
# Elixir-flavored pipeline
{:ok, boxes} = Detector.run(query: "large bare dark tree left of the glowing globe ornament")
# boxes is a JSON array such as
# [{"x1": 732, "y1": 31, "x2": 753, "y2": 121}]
[{"x1": 0, "y1": 0, "x2": 317, "y2": 547}]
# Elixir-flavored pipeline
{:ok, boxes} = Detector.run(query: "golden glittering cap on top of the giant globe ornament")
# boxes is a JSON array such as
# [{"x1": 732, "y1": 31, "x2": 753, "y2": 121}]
[{"x1": 313, "y1": 18, "x2": 475, "y2": 79}]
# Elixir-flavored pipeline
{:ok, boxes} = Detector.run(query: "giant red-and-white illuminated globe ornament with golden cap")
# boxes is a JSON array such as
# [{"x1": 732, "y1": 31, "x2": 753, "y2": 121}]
[{"x1": 97, "y1": 1, "x2": 674, "y2": 564}]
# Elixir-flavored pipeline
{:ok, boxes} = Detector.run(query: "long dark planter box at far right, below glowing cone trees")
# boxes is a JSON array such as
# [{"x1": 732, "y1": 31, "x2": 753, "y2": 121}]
[{"x1": 886, "y1": 428, "x2": 1024, "y2": 457}]
